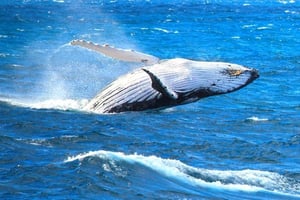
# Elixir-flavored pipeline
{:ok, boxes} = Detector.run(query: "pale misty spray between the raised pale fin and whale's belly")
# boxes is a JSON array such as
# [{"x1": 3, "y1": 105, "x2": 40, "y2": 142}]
[{"x1": 25, "y1": 40, "x2": 136, "y2": 101}]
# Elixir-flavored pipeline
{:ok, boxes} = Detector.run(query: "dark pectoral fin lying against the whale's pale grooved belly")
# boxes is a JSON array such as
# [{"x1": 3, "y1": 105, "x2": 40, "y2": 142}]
[{"x1": 142, "y1": 68, "x2": 178, "y2": 100}]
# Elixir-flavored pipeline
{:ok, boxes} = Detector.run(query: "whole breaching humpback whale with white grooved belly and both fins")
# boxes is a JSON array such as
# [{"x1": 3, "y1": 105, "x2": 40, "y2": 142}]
[{"x1": 71, "y1": 40, "x2": 259, "y2": 113}]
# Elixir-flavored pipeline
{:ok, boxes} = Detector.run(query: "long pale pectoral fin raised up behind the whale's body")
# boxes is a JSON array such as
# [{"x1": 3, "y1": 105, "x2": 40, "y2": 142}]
[{"x1": 70, "y1": 40, "x2": 159, "y2": 65}]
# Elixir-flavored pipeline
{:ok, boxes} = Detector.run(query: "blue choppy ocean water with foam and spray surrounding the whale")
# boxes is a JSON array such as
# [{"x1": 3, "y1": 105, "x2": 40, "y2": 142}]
[{"x1": 0, "y1": 0, "x2": 300, "y2": 199}]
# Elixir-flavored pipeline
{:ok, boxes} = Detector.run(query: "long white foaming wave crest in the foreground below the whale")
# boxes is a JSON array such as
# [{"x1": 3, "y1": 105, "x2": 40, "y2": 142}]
[{"x1": 64, "y1": 150, "x2": 300, "y2": 197}]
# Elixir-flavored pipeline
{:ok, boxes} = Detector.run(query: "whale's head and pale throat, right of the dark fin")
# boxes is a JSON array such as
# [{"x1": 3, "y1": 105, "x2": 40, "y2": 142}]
[{"x1": 158, "y1": 59, "x2": 259, "y2": 101}]
